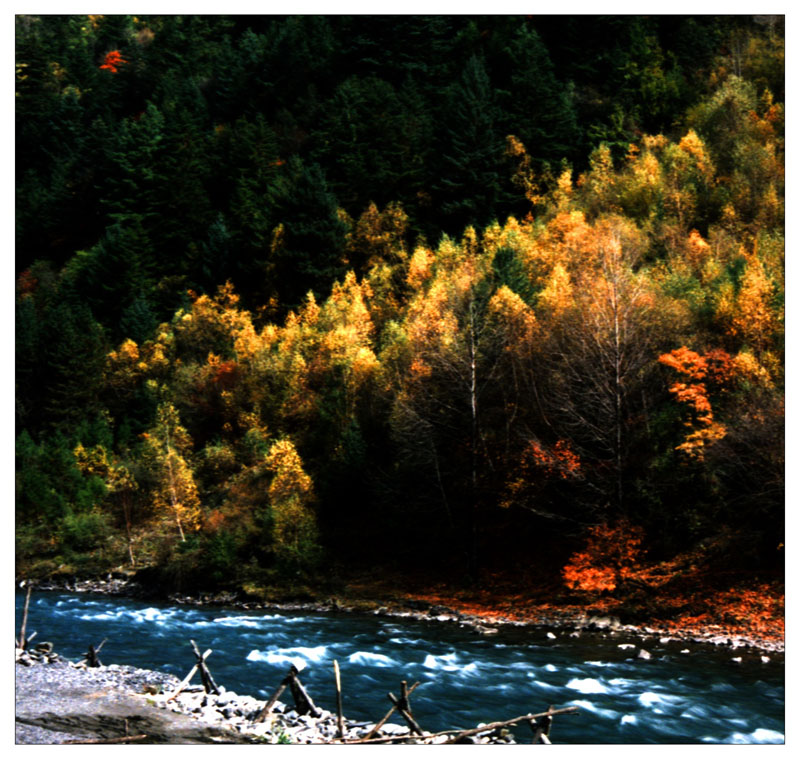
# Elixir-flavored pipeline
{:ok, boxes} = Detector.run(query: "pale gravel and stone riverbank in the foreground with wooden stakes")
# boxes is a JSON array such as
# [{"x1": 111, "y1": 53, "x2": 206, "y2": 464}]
[{"x1": 16, "y1": 651, "x2": 515, "y2": 744}]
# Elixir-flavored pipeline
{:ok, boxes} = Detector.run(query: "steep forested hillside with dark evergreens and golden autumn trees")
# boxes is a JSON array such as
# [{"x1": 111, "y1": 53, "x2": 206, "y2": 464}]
[{"x1": 16, "y1": 11, "x2": 784, "y2": 604}]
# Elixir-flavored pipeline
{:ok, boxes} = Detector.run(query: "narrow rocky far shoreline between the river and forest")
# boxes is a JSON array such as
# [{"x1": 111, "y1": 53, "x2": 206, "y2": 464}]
[{"x1": 26, "y1": 574, "x2": 785, "y2": 658}]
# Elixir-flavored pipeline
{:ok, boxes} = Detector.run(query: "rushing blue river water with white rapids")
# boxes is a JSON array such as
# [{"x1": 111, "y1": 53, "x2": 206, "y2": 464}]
[{"x1": 16, "y1": 592, "x2": 784, "y2": 744}]
